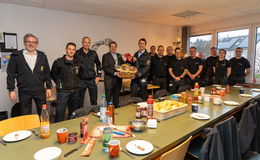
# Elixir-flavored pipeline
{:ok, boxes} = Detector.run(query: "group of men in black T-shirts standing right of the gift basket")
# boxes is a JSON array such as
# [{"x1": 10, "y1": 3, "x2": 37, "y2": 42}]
[{"x1": 149, "y1": 45, "x2": 250, "y2": 93}]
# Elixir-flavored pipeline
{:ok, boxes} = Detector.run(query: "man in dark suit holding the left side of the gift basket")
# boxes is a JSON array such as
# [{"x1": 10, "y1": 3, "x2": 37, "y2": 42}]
[{"x1": 102, "y1": 41, "x2": 124, "y2": 108}]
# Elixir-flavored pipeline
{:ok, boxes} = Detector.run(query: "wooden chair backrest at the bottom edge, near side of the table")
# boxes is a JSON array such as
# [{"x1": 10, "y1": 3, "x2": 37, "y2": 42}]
[{"x1": 160, "y1": 136, "x2": 192, "y2": 160}]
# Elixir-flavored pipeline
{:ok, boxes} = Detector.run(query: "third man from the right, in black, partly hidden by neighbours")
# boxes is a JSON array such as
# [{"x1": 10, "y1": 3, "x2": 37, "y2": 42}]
[{"x1": 203, "y1": 47, "x2": 218, "y2": 85}]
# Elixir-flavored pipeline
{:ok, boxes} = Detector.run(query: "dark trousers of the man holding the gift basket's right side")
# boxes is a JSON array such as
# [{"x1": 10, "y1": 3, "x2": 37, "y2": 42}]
[{"x1": 131, "y1": 77, "x2": 147, "y2": 100}]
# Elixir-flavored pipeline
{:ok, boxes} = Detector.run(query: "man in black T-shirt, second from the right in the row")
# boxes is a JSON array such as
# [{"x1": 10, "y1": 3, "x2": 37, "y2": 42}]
[{"x1": 213, "y1": 49, "x2": 231, "y2": 85}]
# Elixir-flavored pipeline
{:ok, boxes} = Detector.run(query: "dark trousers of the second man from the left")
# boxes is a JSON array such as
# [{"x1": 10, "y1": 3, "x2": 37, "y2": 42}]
[{"x1": 55, "y1": 92, "x2": 80, "y2": 122}]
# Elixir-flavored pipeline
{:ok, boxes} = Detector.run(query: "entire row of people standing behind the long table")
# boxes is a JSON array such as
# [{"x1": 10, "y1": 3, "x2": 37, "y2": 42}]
[{"x1": 7, "y1": 34, "x2": 250, "y2": 122}]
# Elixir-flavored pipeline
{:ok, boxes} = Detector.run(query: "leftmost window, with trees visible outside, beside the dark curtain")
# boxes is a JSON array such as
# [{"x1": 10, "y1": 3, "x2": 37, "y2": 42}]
[{"x1": 189, "y1": 34, "x2": 212, "y2": 57}]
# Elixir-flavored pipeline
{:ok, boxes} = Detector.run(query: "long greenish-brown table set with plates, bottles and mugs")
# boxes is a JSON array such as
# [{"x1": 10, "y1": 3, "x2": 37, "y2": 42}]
[{"x1": 0, "y1": 88, "x2": 259, "y2": 160}]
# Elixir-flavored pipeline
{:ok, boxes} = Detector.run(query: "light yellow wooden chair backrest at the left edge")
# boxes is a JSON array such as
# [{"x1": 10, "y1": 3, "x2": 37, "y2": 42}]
[{"x1": 0, "y1": 114, "x2": 40, "y2": 136}]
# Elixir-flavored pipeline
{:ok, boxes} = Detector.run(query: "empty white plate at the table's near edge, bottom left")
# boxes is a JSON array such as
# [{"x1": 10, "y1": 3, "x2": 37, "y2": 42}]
[{"x1": 33, "y1": 147, "x2": 61, "y2": 160}]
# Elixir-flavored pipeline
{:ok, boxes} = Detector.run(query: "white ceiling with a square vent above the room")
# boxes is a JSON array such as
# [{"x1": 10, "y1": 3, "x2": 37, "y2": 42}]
[{"x1": 0, "y1": 0, "x2": 260, "y2": 26}]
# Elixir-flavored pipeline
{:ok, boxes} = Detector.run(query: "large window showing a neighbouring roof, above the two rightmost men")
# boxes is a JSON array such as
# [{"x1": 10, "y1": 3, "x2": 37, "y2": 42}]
[{"x1": 217, "y1": 29, "x2": 249, "y2": 59}]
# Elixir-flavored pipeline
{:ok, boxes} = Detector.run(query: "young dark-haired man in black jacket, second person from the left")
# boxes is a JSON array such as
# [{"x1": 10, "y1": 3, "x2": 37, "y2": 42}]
[{"x1": 51, "y1": 42, "x2": 81, "y2": 122}]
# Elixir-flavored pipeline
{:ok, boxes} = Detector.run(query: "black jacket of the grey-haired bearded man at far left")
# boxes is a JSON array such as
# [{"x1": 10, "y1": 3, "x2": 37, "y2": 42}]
[{"x1": 6, "y1": 50, "x2": 52, "y2": 92}]
